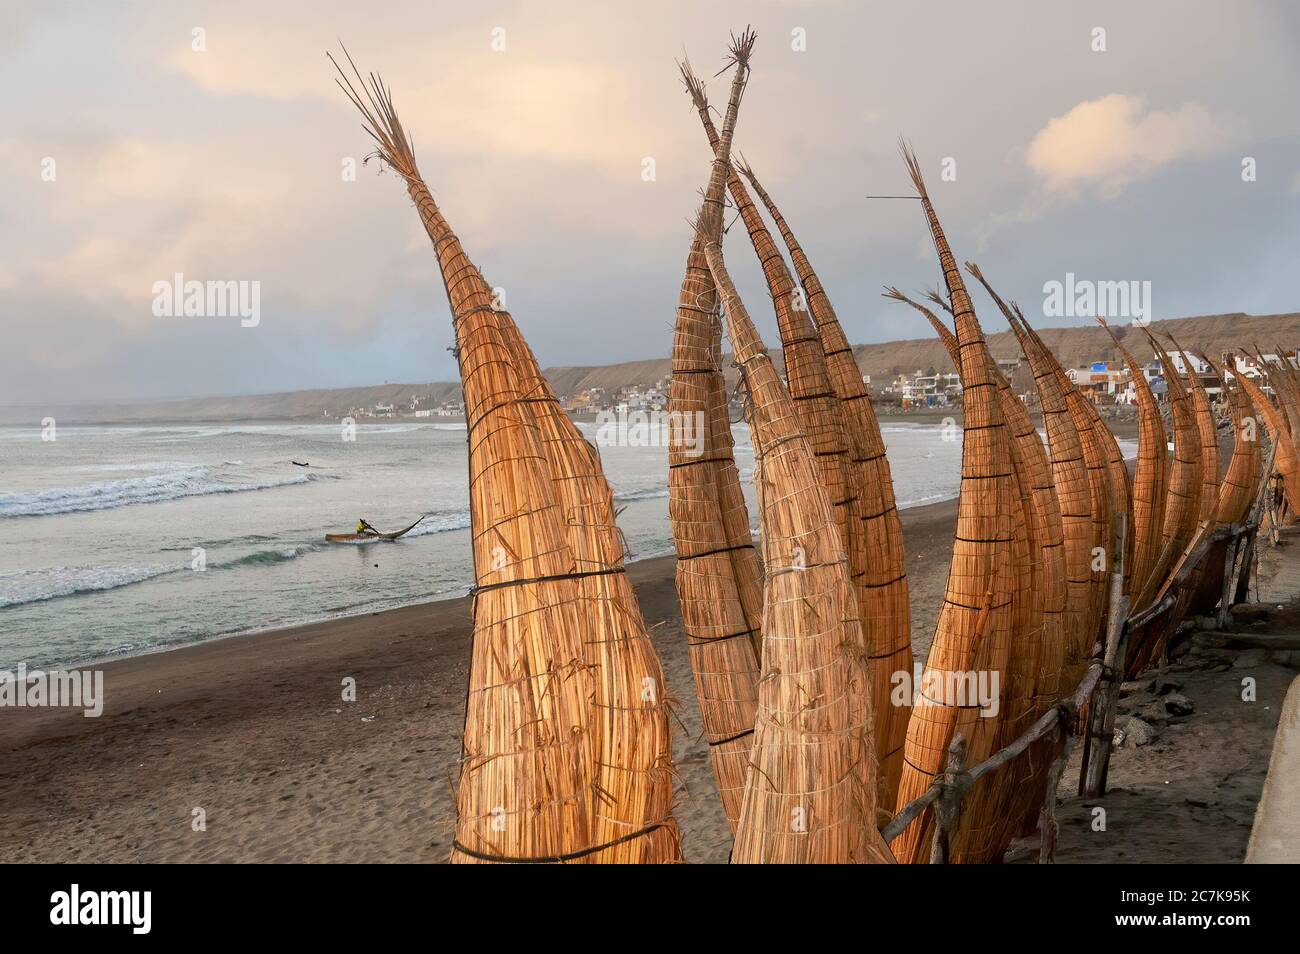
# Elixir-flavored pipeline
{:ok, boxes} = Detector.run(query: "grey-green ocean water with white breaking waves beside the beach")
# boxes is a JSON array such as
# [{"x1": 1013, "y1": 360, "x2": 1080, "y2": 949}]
[{"x1": 0, "y1": 422, "x2": 993, "y2": 668}]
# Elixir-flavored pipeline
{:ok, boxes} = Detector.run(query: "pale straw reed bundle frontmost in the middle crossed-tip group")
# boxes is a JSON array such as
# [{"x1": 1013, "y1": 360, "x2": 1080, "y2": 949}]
[{"x1": 697, "y1": 30, "x2": 892, "y2": 863}]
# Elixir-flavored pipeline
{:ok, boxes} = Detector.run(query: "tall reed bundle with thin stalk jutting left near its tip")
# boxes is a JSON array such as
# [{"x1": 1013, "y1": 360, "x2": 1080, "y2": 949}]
[{"x1": 894, "y1": 147, "x2": 1019, "y2": 862}]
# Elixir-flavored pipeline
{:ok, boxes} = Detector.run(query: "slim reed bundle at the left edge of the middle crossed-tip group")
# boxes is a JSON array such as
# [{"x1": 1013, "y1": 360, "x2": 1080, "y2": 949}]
[{"x1": 668, "y1": 231, "x2": 763, "y2": 833}]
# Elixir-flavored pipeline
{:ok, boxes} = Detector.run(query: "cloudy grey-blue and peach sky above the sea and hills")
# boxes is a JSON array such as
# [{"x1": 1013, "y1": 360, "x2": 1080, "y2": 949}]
[{"x1": 0, "y1": 0, "x2": 1300, "y2": 404}]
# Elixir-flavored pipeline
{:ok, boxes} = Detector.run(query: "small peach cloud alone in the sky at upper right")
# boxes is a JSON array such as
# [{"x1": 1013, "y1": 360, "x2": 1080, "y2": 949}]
[{"x1": 1026, "y1": 94, "x2": 1232, "y2": 198}]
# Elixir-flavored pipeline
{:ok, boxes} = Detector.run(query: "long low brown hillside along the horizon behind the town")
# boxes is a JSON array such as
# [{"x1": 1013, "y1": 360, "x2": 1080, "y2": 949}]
[{"x1": 0, "y1": 312, "x2": 1300, "y2": 424}]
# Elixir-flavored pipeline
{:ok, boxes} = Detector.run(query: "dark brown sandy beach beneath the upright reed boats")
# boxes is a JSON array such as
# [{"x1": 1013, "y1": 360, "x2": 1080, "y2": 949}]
[{"x1": 0, "y1": 478, "x2": 1294, "y2": 863}]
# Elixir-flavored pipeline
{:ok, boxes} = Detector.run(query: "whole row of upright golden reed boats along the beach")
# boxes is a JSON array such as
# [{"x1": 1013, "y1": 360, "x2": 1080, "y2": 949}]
[{"x1": 332, "y1": 30, "x2": 1300, "y2": 863}]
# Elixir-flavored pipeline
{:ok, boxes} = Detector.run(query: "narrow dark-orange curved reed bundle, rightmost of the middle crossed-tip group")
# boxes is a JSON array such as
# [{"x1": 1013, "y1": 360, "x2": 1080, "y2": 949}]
[{"x1": 740, "y1": 158, "x2": 911, "y2": 810}]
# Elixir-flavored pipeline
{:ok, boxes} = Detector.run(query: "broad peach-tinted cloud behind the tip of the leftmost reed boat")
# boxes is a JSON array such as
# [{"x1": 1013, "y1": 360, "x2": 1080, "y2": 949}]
[{"x1": 164, "y1": 18, "x2": 698, "y2": 181}]
